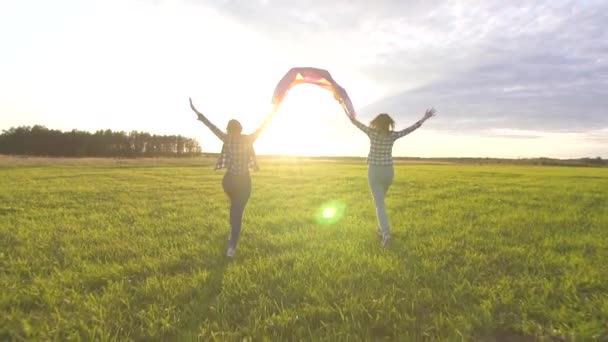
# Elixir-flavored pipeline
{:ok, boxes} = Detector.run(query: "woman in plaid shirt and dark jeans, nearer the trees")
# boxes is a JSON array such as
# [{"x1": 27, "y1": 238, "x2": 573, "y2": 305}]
[{"x1": 190, "y1": 99, "x2": 274, "y2": 258}]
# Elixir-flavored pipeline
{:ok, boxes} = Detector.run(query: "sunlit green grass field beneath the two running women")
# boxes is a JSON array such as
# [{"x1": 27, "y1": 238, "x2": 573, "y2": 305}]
[{"x1": 0, "y1": 159, "x2": 608, "y2": 341}]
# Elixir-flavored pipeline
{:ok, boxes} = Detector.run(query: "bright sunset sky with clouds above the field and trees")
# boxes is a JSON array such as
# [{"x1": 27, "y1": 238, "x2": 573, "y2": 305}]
[{"x1": 0, "y1": 0, "x2": 608, "y2": 158}]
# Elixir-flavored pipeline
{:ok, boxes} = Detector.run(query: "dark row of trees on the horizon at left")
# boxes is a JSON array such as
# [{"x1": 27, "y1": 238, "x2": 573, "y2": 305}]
[{"x1": 0, "y1": 125, "x2": 202, "y2": 157}]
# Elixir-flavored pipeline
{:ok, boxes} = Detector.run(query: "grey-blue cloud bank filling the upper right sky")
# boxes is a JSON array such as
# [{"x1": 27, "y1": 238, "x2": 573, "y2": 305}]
[{"x1": 360, "y1": 2, "x2": 608, "y2": 133}]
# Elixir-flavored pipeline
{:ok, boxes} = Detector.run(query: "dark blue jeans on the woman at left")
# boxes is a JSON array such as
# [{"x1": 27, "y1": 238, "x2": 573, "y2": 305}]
[{"x1": 222, "y1": 173, "x2": 251, "y2": 248}]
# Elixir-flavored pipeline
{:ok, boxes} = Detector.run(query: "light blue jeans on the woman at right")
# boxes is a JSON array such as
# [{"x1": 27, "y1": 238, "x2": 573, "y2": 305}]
[{"x1": 367, "y1": 165, "x2": 395, "y2": 234}]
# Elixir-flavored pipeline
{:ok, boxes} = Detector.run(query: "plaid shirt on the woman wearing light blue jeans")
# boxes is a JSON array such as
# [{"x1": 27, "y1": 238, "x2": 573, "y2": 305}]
[{"x1": 351, "y1": 119, "x2": 422, "y2": 165}]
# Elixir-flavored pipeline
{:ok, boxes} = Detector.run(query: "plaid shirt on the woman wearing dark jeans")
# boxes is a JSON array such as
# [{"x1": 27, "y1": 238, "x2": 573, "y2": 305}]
[{"x1": 201, "y1": 118, "x2": 264, "y2": 175}]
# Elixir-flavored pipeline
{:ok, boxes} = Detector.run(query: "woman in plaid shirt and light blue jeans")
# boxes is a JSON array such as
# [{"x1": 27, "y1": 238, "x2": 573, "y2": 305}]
[{"x1": 351, "y1": 108, "x2": 435, "y2": 247}]
